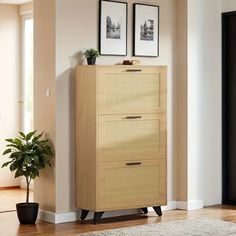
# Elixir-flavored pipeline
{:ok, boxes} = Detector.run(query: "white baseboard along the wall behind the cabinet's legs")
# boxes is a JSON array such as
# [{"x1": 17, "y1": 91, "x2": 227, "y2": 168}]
[{"x1": 38, "y1": 201, "x2": 203, "y2": 224}]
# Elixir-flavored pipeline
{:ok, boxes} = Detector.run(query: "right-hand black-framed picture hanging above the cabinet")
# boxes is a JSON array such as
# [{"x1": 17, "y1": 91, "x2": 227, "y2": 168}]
[{"x1": 133, "y1": 3, "x2": 159, "y2": 57}]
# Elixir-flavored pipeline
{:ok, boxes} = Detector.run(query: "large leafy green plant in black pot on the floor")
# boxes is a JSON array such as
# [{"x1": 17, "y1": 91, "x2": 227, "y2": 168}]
[{"x1": 2, "y1": 130, "x2": 53, "y2": 224}]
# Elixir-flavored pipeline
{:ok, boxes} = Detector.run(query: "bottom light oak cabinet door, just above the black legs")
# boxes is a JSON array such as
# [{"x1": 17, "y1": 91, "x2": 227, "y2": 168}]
[{"x1": 98, "y1": 159, "x2": 166, "y2": 211}]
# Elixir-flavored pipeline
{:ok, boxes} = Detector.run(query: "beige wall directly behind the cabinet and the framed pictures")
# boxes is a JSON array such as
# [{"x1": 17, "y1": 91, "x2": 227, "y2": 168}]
[{"x1": 56, "y1": 0, "x2": 177, "y2": 212}]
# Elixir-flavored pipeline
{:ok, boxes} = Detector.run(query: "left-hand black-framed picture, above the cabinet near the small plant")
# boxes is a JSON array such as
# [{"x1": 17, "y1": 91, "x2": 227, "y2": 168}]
[{"x1": 99, "y1": 0, "x2": 127, "y2": 56}]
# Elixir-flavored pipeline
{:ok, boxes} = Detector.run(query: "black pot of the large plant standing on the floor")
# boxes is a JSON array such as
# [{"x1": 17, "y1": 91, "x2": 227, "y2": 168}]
[{"x1": 16, "y1": 202, "x2": 39, "y2": 224}]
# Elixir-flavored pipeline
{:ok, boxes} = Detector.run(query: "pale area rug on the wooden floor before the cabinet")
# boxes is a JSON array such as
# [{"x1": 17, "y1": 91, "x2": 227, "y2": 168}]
[{"x1": 79, "y1": 218, "x2": 236, "y2": 236}]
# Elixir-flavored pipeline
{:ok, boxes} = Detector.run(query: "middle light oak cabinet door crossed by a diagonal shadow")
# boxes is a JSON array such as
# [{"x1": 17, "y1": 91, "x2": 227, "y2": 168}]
[{"x1": 98, "y1": 114, "x2": 166, "y2": 162}]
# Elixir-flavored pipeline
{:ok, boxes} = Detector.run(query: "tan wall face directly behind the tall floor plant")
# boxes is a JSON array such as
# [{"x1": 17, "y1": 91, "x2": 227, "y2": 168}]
[{"x1": 34, "y1": 0, "x2": 56, "y2": 211}]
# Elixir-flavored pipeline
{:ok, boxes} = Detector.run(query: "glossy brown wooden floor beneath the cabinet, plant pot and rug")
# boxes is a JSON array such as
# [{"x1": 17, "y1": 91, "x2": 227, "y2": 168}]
[{"x1": 0, "y1": 190, "x2": 236, "y2": 236}]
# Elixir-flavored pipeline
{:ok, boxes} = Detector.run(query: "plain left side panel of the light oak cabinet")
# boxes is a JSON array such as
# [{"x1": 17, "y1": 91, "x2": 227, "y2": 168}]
[{"x1": 76, "y1": 66, "x2": 97, "y2": 211}]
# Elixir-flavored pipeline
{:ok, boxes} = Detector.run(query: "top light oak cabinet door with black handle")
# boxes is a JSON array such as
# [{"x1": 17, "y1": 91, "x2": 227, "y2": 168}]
[{"x1": 98, "y1": 68, "x2": 166, "y2": 114}]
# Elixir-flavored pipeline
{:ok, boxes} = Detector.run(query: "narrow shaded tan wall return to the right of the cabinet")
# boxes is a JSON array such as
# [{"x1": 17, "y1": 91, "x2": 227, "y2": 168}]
[{"x1": 173, "y1": 0, "x2": 188, "y2": 202}]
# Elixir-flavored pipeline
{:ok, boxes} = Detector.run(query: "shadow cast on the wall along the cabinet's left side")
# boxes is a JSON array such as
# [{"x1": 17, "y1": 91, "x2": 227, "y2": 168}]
[{"x1": 56, "y1": 68, "x2": 76, "y2": 211}]
